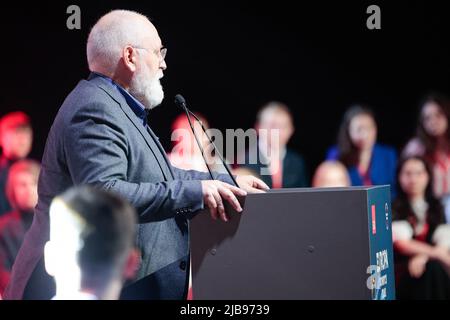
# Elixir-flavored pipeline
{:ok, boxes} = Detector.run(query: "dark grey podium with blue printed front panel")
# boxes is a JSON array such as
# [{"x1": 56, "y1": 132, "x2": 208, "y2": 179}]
[{"x1": 190, "y1": 186, "x2": 395, "y2": 300}]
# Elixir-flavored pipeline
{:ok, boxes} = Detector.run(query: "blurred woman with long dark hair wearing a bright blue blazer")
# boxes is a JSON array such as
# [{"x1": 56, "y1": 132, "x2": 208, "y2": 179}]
[{"x1": 327, "y1": 105, "x2": 397, "y2": 196}]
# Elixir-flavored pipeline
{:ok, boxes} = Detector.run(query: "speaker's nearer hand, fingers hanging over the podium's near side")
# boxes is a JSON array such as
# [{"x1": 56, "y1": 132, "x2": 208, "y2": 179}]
[{"x1": 201, "y1": 180, "x2": 247, "y2": 221}]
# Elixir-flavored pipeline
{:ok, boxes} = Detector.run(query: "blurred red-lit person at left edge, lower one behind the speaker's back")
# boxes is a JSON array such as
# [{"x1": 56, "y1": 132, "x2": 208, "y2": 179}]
[{"x1": 0, "y1": 160, "x2": 40, "y2": 294}]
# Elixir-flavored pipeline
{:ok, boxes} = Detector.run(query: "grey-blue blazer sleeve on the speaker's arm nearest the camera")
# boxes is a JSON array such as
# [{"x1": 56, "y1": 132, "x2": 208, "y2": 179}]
[{"x1": 64, "y1": 104, "x2": 204, "y2": 222}]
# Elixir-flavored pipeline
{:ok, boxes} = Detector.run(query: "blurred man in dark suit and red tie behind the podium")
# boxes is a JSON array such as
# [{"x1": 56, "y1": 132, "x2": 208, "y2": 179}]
[{"x1": 242, "y1": 102, "x2": 309, "y2": 189}]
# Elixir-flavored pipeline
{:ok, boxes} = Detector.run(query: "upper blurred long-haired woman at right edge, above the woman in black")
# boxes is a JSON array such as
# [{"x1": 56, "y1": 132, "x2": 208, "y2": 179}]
[{"x1": 402, "y1": 93, "x2": 450, "y2": 197}]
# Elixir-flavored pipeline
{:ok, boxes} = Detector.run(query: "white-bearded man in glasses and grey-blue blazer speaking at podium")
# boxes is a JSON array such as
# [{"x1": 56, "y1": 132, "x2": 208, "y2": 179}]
[{"x1": 4, "y1": 10, "x2": 268, "y2": 299}]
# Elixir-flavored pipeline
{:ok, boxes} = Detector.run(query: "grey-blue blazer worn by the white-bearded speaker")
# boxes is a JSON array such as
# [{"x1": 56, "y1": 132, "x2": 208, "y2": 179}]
[{"x1": 5, "y1": 75, "x2": 232, "y2": 299}]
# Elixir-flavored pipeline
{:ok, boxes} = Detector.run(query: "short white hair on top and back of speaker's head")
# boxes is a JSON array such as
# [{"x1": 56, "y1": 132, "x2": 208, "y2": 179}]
[{"x1": 86, "y1": 10, "x2": 150, "y2": 72}]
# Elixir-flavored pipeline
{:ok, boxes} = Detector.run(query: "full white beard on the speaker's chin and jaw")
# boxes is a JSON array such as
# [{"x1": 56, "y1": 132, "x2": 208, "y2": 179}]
[{"x1": 129, "y1": 63, "x2": 164, "y2": 110}]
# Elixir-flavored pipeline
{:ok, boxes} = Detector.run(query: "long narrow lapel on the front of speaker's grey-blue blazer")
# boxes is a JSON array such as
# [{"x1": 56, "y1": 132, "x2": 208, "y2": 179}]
[{"x1": 89, "y1": 73, "x2": 173, "y2": 181}]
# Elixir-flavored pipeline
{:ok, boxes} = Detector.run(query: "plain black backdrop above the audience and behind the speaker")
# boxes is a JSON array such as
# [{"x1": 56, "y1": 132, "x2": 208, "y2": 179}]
[{"x1": 0, "y1": 0, "x2": 450, "y2": 176}]
